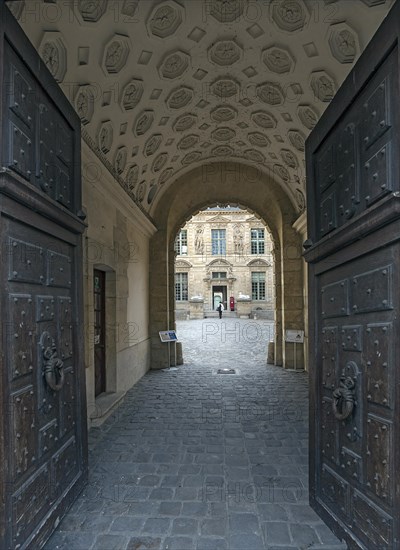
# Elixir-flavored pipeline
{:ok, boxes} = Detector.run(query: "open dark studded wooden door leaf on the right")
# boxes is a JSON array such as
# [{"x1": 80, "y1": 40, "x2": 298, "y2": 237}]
[{"x1": 305, "y1": 2, "x2": 400, "y2": 550}]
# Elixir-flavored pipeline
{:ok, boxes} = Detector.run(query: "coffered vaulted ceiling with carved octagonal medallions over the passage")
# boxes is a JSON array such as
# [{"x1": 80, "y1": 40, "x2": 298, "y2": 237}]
[{"x1": 9, "y1": 0, "x2": 392, "y2": 218}]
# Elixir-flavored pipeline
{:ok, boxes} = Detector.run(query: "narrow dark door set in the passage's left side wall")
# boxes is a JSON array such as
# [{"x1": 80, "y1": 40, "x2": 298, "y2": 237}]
[{"x1": 93, "y1": 269, "x2": 106, "y2": 397}]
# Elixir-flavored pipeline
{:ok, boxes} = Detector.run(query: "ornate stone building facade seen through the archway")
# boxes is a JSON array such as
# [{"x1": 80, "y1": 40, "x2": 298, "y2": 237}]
[{"x1": 175, "y1": 207, "x2": 274, "y2": 319}]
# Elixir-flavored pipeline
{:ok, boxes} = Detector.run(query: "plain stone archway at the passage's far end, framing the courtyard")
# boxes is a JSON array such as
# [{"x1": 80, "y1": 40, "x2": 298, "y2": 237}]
[{"x1": 150, "y1": 162, "x2": 304, "y2": 369}]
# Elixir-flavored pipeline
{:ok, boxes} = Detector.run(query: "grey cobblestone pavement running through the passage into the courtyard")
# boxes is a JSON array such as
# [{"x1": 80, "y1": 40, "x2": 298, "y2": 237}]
[{"x1": 45, "y1": 318, "x2": 346, "y2": 550}]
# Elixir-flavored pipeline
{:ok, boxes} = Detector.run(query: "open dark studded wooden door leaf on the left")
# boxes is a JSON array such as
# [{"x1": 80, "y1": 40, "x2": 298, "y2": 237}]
[{"x1": 0, "y1": 3, "x2": 87, "y2": 550}]
